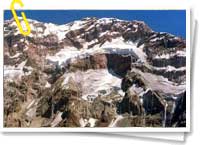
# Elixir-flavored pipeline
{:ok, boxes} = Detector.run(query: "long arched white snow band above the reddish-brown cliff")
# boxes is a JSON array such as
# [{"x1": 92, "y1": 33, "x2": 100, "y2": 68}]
[{"x1": 46, "y1": 37, "x2": 147, "y2": 65}]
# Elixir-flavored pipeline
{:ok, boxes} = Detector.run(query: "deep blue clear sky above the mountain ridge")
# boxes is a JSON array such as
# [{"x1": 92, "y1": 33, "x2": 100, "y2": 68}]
[{"x1": 4, "y1": 10, "x2": 186, "y2": 38}]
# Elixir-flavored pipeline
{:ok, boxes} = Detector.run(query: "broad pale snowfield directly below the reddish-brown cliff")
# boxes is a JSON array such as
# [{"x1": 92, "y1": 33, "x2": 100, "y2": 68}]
[{"x1": 62, "y1": 69, "x2": 122, "y2": 100}]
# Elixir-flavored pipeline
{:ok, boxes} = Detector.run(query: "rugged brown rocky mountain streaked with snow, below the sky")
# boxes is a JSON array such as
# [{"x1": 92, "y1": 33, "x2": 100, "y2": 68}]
[{"x1": 4, "y1": 18, "x2": 186, "y2": 127}]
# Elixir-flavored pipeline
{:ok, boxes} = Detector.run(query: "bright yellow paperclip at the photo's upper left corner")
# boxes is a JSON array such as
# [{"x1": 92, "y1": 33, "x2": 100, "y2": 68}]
[{"x1": 10, "y1": 0, "x2": 31, "y2": 36}]
